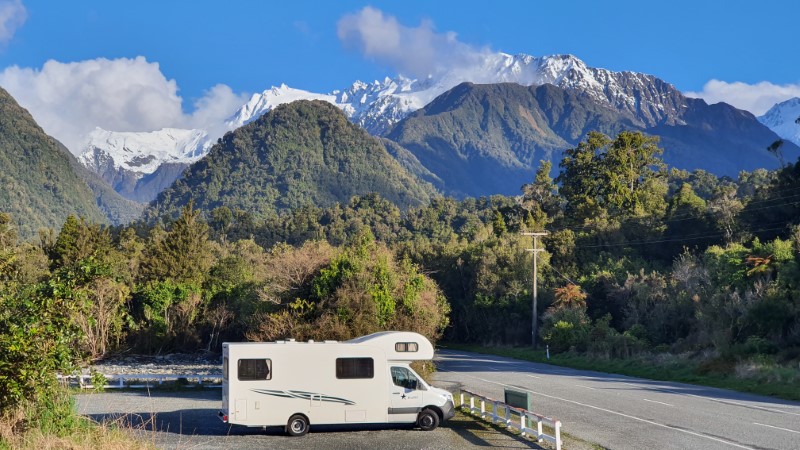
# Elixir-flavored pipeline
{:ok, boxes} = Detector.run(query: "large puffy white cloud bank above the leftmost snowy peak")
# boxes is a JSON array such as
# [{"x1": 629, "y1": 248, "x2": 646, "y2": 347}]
[{"x1": 0, "y1": 56, "x2": 247, "y2": 153}]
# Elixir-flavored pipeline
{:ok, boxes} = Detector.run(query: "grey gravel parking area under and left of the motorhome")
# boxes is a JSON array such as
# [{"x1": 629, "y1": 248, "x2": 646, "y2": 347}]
[{"x1": 76, "y1": 389, "x2": 541, "y2": 450}]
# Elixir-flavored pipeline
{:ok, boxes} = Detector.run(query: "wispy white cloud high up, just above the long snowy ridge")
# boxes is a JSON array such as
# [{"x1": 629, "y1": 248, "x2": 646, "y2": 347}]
[{"x1": 337, "y1": 6, "x2": 489, "y2": 77}]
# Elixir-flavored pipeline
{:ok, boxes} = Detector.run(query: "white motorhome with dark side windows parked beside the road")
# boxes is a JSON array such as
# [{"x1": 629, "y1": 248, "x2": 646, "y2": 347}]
[{"x1": 219, "y1": 331, "x2": 455, "y2": 436}]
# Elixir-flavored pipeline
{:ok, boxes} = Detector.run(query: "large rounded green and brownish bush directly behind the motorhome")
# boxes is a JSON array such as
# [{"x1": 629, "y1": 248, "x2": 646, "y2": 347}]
[{"x1": 246, "y1": 233, "x2": 449, "y2": 341}]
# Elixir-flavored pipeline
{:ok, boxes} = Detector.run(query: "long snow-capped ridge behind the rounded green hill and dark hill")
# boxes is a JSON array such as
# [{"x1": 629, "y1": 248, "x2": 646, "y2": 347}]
[{"x1": 227, "y1": 53, "x2": 685, "y2": 135}]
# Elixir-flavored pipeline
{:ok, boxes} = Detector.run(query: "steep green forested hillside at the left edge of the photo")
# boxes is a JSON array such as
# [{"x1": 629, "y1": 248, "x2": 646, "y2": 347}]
[{"x1": 0, "y1": 88, "x2": 108, "y2": 238}]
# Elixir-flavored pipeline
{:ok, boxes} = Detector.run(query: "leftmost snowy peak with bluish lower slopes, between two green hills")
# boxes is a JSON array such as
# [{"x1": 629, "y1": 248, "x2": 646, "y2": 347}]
[{"x1": 78, "y1": 128, "x2": 211, "y2": 203}]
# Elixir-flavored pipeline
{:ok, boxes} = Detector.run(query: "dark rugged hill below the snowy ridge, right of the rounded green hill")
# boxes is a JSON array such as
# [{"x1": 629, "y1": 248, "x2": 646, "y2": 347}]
[{"x1": 387, "y1": 83, "x2": 634, "y2": 197}]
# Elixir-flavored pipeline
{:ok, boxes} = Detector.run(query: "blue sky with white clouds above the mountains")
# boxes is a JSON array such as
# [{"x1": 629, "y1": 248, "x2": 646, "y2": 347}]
[{"x1": 0, "y1": 0, "x2": 800, "y2": 151}]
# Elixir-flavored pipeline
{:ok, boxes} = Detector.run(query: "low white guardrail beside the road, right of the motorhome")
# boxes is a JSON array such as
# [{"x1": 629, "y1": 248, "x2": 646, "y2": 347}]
[{"x1": 459, "y1": 389, "x2": 561, "y2": 450}]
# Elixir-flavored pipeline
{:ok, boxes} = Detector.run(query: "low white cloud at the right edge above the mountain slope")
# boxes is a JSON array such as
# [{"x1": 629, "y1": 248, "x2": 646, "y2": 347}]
[{"x1": 684, "y1": 80, "x2": 800, "y2": 116}]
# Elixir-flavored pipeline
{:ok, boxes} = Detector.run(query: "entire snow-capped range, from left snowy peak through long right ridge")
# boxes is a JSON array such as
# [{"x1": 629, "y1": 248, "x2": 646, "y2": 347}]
[{"x1": 79, "y1": 53, "x2": 686, "y2": 201}]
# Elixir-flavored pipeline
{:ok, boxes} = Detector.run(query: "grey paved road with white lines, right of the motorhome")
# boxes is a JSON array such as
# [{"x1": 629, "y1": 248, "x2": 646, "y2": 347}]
[{"x1": 435, "y1": 350, "x2": 800, "y2": 450}]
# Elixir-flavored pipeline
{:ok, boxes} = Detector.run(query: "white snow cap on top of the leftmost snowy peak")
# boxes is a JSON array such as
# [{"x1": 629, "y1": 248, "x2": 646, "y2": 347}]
[{"x1": 78, "y1": 128, "x2": 210, "y2": 174}]
